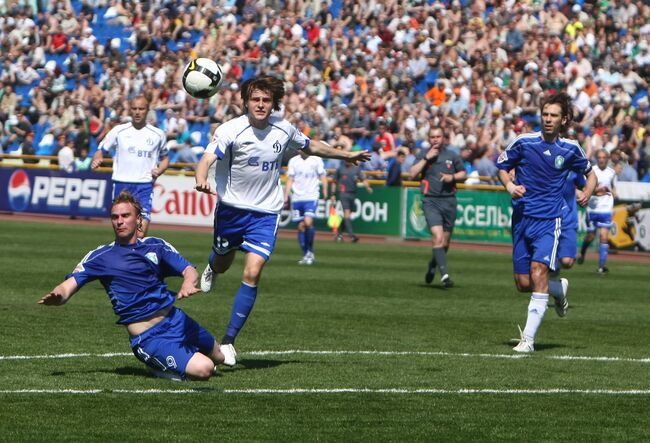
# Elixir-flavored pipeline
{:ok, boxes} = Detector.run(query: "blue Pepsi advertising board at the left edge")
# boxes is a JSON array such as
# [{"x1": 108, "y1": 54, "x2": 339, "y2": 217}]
[{"x1": 0, "y1": 168, "x2": 112, "y2": 217}]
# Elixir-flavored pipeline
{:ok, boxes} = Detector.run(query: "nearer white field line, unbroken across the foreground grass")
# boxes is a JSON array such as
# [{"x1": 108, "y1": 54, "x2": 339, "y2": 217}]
[{"x1": 0, "y1": 388, "x2": 650, "y2": 396}]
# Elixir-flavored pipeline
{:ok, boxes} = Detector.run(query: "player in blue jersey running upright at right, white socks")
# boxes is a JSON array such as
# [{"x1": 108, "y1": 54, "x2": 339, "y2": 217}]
[{"x1": 497, "y1": 93, "x2": 596, "y2": 352}]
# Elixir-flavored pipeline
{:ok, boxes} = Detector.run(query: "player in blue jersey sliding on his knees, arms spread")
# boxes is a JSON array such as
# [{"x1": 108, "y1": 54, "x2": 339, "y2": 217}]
[{"x1": 38, "y1": 191, "x2": 223, "y2": 380}]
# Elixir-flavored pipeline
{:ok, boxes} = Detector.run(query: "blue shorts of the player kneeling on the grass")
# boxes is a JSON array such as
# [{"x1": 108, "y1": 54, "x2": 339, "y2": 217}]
[{"x1": 131, "y1": 307, "x2": 215, "y2": 378}]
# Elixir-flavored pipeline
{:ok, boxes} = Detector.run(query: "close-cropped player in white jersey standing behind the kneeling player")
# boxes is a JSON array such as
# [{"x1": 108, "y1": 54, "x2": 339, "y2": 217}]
[{"x1": 91, "y1": 95, "x2": 169, "y2": 238}]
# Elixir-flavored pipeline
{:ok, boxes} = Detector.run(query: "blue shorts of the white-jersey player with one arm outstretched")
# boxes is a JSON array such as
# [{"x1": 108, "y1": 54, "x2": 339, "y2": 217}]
[{"x1": 212, "y1": 203, "x2": 280, "y2": 260}]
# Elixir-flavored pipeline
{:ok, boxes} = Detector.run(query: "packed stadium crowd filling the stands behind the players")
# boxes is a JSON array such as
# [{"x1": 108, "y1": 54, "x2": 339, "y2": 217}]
[{"x1": 0, "y1": 0, "x2": 650, "y2": 183}]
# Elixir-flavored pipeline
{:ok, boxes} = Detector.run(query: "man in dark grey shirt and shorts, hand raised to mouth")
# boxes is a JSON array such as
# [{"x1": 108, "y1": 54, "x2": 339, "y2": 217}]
[{"x1": 410, "y1": 127, "x2": 467, "y2": 288}]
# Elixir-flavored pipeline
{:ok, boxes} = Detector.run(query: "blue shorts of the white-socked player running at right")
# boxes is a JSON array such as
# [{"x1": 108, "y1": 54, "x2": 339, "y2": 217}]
[{"x1": 512, "y1": 211, "x2": 562, "y2": 274}]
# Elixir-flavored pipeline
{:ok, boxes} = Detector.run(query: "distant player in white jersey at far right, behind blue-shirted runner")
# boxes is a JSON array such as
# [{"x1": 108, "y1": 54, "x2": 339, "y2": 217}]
[{"x1": 578, "y1": 149, "x2": 616, "y2": 275}]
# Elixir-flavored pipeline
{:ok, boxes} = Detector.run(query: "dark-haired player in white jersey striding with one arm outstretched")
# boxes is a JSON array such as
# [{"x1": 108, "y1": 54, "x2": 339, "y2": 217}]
[{"x1": 196, "y1": 76, "x2": 370, "y2": 366}]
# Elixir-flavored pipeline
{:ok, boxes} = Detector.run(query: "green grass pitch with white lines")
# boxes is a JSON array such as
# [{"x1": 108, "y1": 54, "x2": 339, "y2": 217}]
[{"x1": 0, "y1": 221, "x2": 650, "y2": 442}]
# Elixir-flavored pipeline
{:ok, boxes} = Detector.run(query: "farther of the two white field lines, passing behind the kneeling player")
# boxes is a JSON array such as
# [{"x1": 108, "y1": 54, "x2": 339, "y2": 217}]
[{"x1": 0, "y1": 349, "x2": 650, "y2": 363}]
